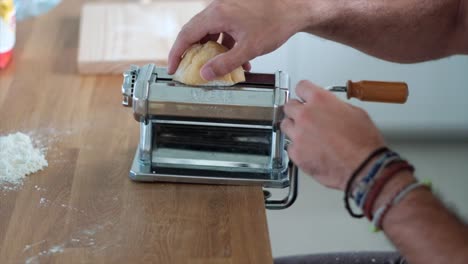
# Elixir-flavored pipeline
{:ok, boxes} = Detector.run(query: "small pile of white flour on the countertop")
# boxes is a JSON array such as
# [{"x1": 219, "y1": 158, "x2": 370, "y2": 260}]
[{"x1": 0, "y1": 132, "x2": 48, "y2": 185}]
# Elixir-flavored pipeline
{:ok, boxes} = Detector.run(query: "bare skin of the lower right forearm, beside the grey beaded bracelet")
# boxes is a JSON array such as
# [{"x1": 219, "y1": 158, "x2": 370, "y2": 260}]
[{"x1": 374, "y1": 172, "x2": 468, "y2": 264}]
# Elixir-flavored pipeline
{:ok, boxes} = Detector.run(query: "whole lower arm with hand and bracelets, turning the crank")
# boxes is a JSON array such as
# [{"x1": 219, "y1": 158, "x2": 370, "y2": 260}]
[{"x1": 281, "y1": 81, "x2": 468, "y2": 264}]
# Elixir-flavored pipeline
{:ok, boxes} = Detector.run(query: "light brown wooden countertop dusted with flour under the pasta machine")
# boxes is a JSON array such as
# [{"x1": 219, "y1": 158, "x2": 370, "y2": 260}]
[{"x1": 0, "y1": 0, "x2": 272, "y2": 263}]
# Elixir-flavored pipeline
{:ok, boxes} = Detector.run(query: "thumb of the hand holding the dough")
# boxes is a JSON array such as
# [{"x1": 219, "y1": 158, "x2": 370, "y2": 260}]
[{"x1": 200, "y1": 44, "x2": 250, "y2": 81}]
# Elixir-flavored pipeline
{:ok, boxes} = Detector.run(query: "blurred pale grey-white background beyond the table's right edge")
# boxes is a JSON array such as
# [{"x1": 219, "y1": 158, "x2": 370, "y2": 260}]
[{"x1": 252, "y1": 33, "x2": 468, "y2": 256}]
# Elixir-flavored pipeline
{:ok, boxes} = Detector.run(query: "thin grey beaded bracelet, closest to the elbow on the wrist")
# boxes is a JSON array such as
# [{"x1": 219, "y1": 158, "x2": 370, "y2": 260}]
[{"x1": 372, "y1": 181, "x2": 432, "y2": 232}]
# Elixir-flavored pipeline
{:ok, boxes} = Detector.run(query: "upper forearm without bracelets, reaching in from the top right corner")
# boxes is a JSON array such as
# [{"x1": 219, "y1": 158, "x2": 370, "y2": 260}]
[{"x1": 302, "y1": 0, "x2": 468, "y2": 62}]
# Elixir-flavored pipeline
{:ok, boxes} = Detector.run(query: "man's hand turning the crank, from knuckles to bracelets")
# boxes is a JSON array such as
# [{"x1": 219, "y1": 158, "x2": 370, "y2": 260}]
[{"x1": 281, "y1": 81, "x2": 385, "y2": 190}]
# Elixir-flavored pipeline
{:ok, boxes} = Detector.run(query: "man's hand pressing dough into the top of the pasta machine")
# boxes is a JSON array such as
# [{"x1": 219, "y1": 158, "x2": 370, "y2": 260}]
[{"x1": 168, "y1": 0, "x2": 308, "y2": 80}]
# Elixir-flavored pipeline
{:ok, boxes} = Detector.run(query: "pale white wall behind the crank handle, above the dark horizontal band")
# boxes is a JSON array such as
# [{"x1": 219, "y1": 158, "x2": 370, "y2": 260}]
[{"x1": 252, "y1": 33, "x2": 468, "y2": 135}]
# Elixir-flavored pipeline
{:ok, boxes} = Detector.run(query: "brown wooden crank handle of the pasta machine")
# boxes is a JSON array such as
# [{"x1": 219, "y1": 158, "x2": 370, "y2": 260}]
[{"x1": 347, "y1": 81, "x2": 408, "y2": 104}]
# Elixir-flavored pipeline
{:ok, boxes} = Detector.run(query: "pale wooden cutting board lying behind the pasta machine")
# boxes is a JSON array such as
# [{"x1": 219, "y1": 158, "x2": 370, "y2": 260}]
[{"x1": 78, "y1": 1, "x2": 206, "y2": 74}]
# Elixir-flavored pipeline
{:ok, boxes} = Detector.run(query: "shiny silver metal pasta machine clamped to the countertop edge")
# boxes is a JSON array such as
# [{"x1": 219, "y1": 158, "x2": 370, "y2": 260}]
[{"x1": 122, "y1": 64, "x2": 298, "y2": 209}]
